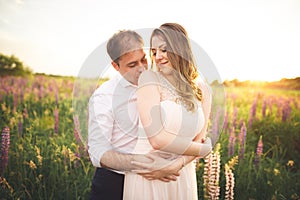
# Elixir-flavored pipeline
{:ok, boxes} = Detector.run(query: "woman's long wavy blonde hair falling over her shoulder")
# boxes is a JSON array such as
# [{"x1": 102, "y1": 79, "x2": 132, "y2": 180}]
[{"x1": 150, "y1": 23, "x2": 202, "y2": 111}]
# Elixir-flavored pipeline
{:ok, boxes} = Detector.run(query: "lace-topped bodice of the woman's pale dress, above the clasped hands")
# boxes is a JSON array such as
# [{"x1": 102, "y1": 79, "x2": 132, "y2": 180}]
[{"x1": 135, "y1": 72, "x2": 204, "y2": 157}]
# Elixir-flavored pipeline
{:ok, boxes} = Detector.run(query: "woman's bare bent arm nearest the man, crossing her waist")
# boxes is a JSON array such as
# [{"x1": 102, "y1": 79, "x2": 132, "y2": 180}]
[{"x1": 137, "y1": 71, "x2": 212, "y2": 157}]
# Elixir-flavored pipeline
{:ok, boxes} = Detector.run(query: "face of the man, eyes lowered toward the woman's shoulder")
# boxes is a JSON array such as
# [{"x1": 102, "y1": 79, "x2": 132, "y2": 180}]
[{"x1": 112, "y1": 49, "x2": 148, "y2": 85}]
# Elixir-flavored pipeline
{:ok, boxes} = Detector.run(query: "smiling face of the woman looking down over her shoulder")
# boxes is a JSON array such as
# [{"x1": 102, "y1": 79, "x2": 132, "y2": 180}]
[{"x1": 151, "y1": 36, "x2": 173, "y2": 74}]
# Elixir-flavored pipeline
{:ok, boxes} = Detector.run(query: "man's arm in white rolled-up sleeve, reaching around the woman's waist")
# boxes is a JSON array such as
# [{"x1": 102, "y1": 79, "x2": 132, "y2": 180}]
[{"x1": 88, "y1": 92, "x2": 180, "y2": 180}]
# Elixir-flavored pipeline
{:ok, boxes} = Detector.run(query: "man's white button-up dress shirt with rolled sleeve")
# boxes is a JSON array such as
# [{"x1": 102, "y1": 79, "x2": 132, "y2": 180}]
[{"x1": 88, "y1": 73, "x2": 139, "y2": 167}]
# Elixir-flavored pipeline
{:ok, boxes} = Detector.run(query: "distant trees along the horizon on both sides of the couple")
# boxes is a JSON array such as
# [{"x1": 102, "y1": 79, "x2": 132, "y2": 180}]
[{"x1": 0, "y1": 53, "x2": 300, "y2": 90}]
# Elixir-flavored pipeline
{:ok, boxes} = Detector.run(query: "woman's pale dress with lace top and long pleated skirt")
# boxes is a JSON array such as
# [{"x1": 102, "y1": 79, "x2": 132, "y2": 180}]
[{"x1": 123, "y1": 73, "x2": 204, "y2": 200}]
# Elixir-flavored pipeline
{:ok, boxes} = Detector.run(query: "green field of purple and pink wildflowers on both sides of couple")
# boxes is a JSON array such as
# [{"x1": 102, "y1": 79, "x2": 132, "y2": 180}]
[{"x1": 0, "y1": 75, "x2": 300, "y2": 199}]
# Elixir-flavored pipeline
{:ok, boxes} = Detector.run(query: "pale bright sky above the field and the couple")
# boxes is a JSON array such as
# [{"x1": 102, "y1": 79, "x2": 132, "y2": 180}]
[{"x1": 0, "y1": 0, "x2": 300, "y2": 81}]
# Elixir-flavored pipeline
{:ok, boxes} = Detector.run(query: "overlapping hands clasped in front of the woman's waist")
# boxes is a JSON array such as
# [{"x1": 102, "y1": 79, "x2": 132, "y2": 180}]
[{"x1": 131, "y1": 152, "x2": 184, "y2": 182}]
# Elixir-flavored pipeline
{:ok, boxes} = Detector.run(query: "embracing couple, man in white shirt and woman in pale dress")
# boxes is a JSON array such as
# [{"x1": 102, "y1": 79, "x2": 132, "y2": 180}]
[{"x1": 88, "y1": 23, "x2": 212, "y2": 200}]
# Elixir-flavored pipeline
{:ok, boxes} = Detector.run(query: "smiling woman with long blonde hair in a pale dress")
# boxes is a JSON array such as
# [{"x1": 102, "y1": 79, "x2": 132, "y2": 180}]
[{"x1": 124, "y1": 23, "x2": 212, "y2": 200}]
